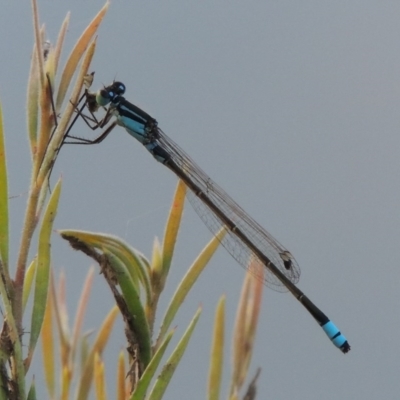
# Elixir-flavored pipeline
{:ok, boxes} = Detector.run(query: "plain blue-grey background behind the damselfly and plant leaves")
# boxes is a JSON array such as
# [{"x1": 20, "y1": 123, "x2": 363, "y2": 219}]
[{"x1": 0, "y1": 0, "x2": 400, "y2": 400}]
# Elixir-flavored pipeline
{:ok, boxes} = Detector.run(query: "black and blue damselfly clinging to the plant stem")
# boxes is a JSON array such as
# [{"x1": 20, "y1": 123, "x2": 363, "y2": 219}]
[{"x1": 65, "y1": 82, "x2": 350, "y2": 353}]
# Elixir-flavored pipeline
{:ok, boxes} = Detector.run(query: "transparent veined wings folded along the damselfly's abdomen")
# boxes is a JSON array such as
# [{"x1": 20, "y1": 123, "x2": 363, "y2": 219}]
[{"x1": 156, "y1": 129, "x2": 300, "y2": 292}]
